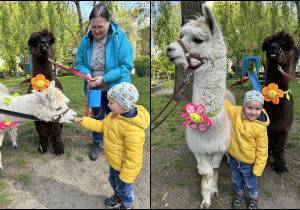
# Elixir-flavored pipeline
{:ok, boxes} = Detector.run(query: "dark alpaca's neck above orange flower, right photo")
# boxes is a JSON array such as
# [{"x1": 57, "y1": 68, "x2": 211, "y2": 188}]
[{"x1": 265, "y1": 59, "x2": 292, "y2": 91}]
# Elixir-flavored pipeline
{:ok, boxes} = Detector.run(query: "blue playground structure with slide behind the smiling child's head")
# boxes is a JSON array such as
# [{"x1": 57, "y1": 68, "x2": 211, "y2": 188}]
[{"x1": 230, "y1": 56, "x2": 264, "y2": 92}]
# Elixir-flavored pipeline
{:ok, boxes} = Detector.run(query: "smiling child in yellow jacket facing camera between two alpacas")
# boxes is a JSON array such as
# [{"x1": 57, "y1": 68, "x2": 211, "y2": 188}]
[{"x1": 225, "y1": 90, "x2": 270, "y2": 209}]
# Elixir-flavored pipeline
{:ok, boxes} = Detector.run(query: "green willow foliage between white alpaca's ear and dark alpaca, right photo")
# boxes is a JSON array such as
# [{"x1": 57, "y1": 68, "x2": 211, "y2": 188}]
[{"x1": 213, "y1": 1, "x2": 297, "y2": 71}]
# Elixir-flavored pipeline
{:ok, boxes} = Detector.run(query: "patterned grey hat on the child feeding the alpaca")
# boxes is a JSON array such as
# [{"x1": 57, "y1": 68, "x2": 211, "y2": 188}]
[{"x1": 107, "y1": 82, "x2": 139, "y2": 109}]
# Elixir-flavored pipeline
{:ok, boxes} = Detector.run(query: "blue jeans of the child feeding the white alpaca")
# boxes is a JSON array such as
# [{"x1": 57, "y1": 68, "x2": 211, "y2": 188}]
[{"x1": 108, "y1": 166, "x2": 134, "y2": 207}]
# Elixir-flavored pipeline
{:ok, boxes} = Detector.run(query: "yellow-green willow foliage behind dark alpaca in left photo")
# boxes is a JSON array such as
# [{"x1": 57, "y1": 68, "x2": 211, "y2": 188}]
[{"x1": 0, "y1": 1, "x2": 79, "y2": 75}]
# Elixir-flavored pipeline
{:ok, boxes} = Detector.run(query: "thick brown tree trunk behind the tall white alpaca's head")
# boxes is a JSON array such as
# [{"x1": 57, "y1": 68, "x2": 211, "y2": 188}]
[{"x1": 174, "y1": 1, "x2": 205, "y2": 102}]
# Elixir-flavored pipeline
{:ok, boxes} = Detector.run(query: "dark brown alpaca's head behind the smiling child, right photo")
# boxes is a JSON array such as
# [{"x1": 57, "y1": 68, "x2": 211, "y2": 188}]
[{"x1": 261, "y1": 31, "x2": 299, "y2": 66}]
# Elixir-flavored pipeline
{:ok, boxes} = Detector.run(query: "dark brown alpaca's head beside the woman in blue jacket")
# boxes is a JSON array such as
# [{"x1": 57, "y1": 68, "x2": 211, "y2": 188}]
[{"x1": 28, "y1": 29, "x2": 55, "y2": 59}]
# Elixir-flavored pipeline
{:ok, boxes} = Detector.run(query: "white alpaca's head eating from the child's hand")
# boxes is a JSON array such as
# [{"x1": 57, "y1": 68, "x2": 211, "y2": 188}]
[{"x1": 32, "y1": 81, "x2": 77, "y2": 123}]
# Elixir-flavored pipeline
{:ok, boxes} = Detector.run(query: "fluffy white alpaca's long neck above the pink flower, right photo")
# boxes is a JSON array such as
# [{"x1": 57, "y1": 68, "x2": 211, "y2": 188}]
[{"x1": 193, "y1": 57, "x2": 227, "y2": 114}]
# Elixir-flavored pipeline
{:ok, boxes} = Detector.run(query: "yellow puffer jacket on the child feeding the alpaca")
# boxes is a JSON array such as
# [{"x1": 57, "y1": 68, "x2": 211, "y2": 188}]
[{"x1": 81, "y1": 105, "x2": 150, "y2": 183}]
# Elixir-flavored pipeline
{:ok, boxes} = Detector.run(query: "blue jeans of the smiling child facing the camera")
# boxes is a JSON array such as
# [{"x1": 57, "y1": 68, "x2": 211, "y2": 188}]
[{"x1": 229, "y1": 154, "x2": 258, "y2": 197}]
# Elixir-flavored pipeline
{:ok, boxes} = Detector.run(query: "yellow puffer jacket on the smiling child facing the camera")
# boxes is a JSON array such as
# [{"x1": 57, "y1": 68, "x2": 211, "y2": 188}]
[{"x1": 224, "y1": 100, "x2": 270, "y2": 176}]
